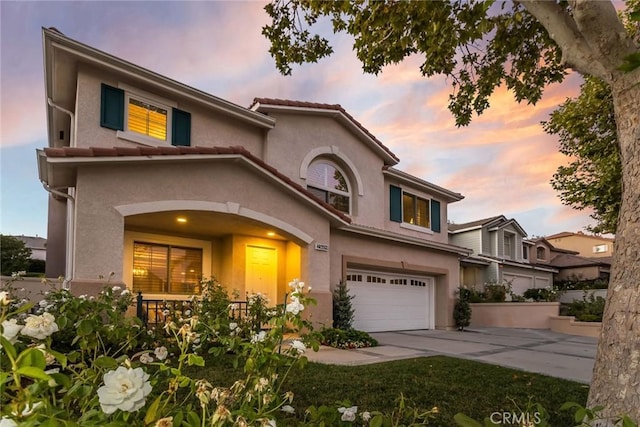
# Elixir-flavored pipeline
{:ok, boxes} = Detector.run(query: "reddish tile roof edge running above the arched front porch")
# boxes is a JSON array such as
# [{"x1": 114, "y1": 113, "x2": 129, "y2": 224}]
[{"x1": 43, "y1": 146, "x2": 351, "y2": 223}]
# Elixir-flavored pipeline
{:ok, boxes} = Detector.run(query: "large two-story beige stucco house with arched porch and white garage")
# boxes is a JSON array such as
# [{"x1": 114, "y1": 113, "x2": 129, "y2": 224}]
[{"x1": 37, "y1": 29, "x2": 470, "y2": 331}]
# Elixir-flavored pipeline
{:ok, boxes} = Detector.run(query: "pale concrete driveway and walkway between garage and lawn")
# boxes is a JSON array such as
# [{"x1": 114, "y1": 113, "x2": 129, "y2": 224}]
[{"x1": 306, "y1": 328, "x2": 597, "y2": 384}]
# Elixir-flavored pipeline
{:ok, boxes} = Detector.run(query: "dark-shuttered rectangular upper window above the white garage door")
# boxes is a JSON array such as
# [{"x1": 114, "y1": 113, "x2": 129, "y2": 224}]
[{"x1": 389, "y1": 185, "x2": 441, "y2": 233}]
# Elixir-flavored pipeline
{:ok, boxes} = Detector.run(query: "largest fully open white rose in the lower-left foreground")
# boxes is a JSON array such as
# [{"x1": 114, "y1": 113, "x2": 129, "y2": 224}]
[{"x1": 98, "y1": 366, "x2": 151, "y2": 414}]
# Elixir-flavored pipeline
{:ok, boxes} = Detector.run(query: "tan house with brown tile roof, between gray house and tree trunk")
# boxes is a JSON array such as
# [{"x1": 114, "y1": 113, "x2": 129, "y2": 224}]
[{"x1": 531, "y1": 237, "x2": 611, "y2": 281}]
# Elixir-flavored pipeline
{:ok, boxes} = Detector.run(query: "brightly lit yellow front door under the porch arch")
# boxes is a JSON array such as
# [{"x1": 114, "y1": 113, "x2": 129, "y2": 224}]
[{"x1": 245, "y1": 245, "x2": 278, "y2": 305}]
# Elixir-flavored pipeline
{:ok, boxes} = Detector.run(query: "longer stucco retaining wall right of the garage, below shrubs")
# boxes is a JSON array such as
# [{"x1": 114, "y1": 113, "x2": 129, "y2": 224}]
[{"x1": 470, "y1": 302, "x2": 560, "y2": 329}]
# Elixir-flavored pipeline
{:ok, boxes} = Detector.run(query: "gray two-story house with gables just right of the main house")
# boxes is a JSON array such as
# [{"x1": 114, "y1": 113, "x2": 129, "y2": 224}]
[{"x1": 449, "y1": 215, "x2": 557, "y2": 295}]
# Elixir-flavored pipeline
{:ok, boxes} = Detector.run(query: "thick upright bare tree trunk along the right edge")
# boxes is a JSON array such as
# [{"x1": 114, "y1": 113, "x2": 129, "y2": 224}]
[{"x1": 588, "y1": 70, "x2": 640, "y2": 426}]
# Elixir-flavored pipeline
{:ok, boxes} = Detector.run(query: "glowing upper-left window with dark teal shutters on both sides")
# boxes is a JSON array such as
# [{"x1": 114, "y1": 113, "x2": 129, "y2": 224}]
[{"x1": 100, "y1": 84, "x2": 191, "y2": 146}]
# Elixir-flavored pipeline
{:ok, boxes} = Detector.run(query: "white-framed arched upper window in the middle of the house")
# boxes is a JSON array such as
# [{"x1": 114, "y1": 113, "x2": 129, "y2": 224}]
[{"x1": 307, "y1": 160, "x2": 351, "y2": 214}]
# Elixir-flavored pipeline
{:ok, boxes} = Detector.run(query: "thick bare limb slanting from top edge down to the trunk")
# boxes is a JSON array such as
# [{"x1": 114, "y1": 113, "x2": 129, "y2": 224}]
[{"x1": 517, "y1": 0, "x2": 611, "y2": 82}]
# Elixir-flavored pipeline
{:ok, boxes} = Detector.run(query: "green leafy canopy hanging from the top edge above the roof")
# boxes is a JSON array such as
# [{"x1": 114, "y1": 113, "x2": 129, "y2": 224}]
[{"x1": 262, "y1": 0, "x2": 566, "y2": 126}]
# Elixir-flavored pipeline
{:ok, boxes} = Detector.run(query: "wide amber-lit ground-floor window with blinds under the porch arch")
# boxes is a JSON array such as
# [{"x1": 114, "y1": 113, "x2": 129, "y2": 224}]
[{"x1": 133, "y1": 242, "x2": 202, "y2": 294}]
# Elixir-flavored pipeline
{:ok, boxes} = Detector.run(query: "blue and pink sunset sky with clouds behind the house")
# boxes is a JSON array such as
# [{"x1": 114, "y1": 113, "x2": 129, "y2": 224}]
[{"x1": 0, "y1": 1, "x2": 592, "y2": 241}]
